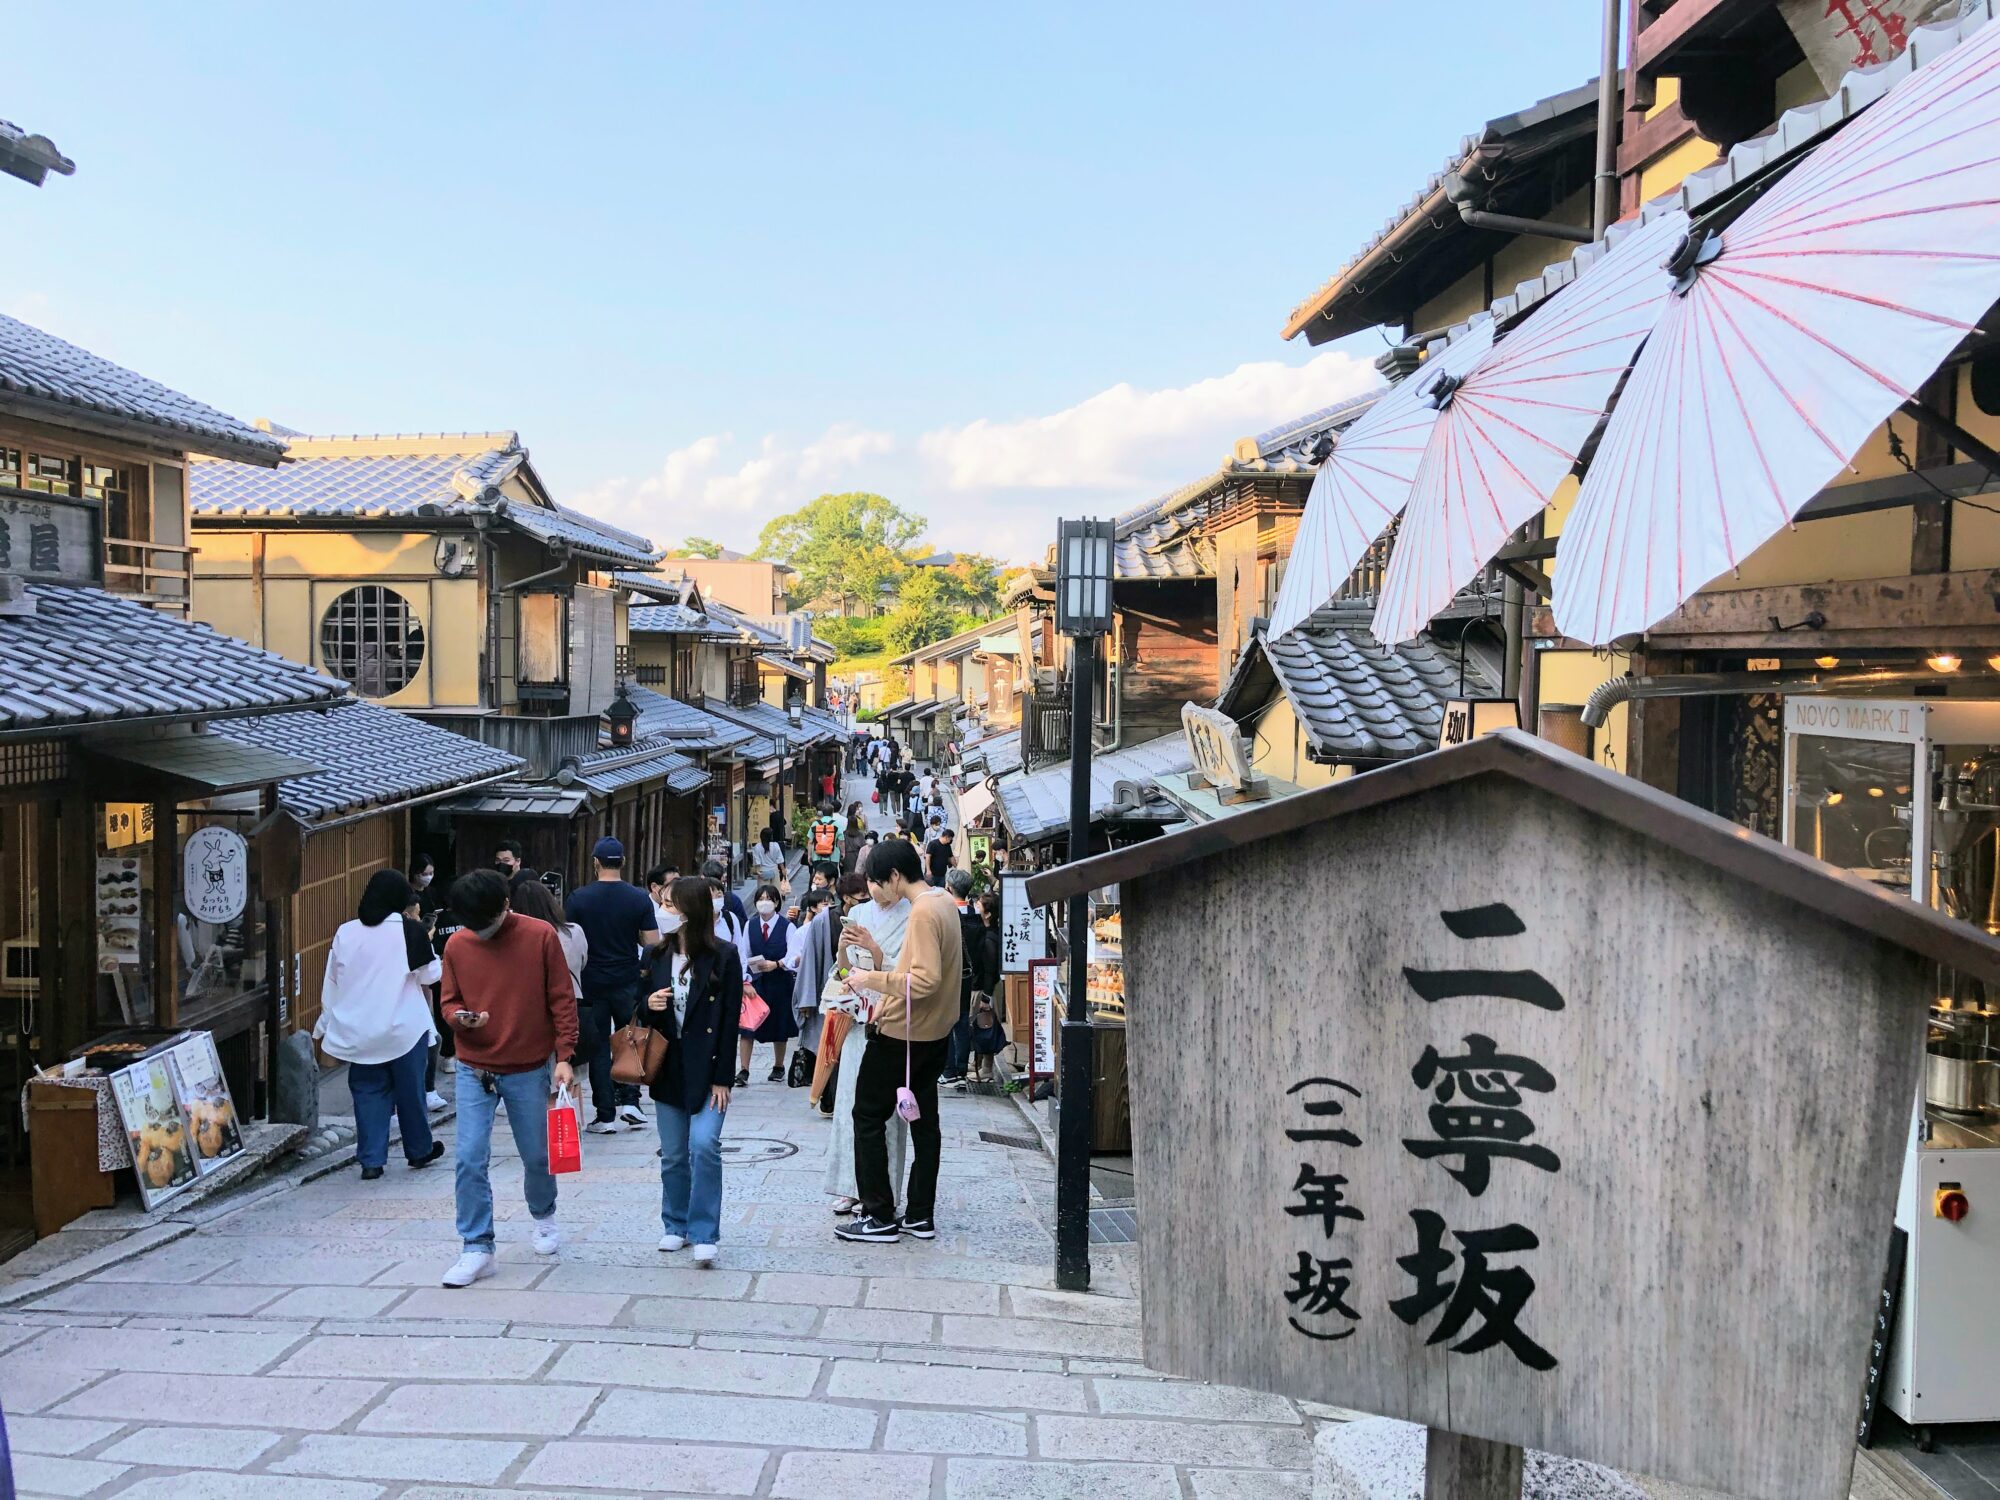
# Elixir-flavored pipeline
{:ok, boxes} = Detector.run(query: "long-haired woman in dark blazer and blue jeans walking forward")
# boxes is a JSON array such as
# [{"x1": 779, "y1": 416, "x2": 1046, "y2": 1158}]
[{"x1": 638, "y1": 878, "x2": 744, "y2": 1268}]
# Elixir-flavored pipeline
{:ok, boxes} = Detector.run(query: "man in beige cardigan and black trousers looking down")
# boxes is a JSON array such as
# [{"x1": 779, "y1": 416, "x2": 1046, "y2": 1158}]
[{"x1": 834, "y1": 838, "x2": 962, "y2": 1244}]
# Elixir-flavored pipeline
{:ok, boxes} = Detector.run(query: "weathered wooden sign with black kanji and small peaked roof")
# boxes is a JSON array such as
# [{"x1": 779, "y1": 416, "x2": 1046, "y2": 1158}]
[{"x1": 1028, "y1": 730, "x2": 2000, "y2": 1500}]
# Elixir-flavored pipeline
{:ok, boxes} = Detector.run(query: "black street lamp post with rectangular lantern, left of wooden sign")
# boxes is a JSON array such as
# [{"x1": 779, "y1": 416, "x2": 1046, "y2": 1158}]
[{"x1": 1056, "y1": 520, "x2": 1112, "y2": 1292}]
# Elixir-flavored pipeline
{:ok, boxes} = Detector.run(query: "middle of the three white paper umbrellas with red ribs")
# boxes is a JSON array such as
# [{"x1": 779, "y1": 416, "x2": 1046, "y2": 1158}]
[{"x1": 1374, "y1": 212, "x2": 1688, "y2": 646}]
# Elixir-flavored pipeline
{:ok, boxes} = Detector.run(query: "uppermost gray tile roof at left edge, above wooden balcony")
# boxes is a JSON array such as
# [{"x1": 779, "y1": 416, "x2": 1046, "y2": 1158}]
[{"x1": 0, "y1": 314, "x2": 284, "y2": 464}]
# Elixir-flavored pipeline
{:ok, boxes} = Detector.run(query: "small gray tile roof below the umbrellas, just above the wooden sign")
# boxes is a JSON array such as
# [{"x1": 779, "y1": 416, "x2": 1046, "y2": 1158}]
[{"x1": 1220, "y1": 608, "x2": 1498, "y2": 760}]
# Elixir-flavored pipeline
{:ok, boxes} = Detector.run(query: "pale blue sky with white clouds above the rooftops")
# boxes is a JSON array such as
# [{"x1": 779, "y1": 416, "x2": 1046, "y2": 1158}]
[{"x1": 0, "y1": 0, "x2": 1598, "y2": 556}]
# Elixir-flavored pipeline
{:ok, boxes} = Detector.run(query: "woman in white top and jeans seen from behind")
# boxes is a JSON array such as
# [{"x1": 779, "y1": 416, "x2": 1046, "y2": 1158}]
[{"x1": 312, "y1": 870, "x2": 444, "y2": 1182}]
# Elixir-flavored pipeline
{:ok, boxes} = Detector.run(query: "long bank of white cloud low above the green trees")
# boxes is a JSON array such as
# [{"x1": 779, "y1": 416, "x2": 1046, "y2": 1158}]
[{"x1": 576, "y1": 352, "x2": 1376, "y2": 560}]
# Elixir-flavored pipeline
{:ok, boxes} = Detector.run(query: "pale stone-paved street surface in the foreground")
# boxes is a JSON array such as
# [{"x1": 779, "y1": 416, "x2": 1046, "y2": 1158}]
[{"x1": 0, "y1": 1050, "x2": 1312, "y2": 1500}]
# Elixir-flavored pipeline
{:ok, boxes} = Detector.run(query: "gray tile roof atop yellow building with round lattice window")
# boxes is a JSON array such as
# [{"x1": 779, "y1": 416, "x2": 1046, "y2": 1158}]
[{"x1": 188, "y1": 444, "x2": 662, "y2": 566}]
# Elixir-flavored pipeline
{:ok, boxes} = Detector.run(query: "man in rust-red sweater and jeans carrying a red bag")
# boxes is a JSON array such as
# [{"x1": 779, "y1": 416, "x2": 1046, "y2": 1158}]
[{"x1": 438, "y1": 870, "x2": 576, "y2": 1286}]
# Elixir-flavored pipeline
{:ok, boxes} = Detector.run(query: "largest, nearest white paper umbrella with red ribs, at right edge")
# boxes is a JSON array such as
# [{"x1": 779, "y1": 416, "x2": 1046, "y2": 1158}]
[{"x1": 1554, "y1": 24, "x2": 2000, "y2": 642}]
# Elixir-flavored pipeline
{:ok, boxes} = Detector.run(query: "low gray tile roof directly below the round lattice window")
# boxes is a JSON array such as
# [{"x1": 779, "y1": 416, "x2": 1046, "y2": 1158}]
[{"x1": 216, "y1": 702, "x2": 526, "y2": 822}]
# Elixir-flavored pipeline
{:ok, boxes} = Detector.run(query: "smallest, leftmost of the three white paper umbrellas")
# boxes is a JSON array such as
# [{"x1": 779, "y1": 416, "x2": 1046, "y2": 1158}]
[{"x1": 1270, "y1": 320, "x2": 1494, "y2": 636}]
